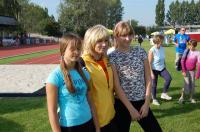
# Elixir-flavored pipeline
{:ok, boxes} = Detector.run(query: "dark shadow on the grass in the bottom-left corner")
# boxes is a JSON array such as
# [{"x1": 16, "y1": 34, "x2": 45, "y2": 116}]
[{"x1": 0, "y1": 117, "x2": 24, "y2": 132}]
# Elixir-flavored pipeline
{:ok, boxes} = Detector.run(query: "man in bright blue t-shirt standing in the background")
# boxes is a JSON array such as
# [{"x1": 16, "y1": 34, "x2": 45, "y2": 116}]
[{"x1": 173, "y1": 27, "x2": 190, "y2": 71}]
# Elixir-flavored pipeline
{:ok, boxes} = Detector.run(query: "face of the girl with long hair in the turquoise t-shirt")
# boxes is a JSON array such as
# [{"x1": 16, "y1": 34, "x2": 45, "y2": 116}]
[{"x1": 64, "y1": 44, "x2": 81, "y2": 64}]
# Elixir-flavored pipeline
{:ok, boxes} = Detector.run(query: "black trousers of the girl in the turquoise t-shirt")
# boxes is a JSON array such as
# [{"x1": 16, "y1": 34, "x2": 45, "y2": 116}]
[{"x1": 60, "y1": 119, "x2": 95, "y2": 132}]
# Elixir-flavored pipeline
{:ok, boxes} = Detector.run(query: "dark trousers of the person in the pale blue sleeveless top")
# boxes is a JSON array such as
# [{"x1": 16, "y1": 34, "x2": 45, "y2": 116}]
[{"x1": 152, "y1": 68, "x2": 172, "y2": 99}]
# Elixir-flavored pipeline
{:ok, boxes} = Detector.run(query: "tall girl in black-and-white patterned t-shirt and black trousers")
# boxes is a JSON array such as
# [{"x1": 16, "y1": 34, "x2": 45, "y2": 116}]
[{"x1": 109, "y1": 21, "x2": 162, "y2": 132}]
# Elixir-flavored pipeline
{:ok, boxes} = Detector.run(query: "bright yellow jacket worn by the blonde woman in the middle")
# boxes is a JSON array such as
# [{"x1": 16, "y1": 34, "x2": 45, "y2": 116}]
[{"x1": 83, "y1": 55, "x2": 115, "y2": 127}]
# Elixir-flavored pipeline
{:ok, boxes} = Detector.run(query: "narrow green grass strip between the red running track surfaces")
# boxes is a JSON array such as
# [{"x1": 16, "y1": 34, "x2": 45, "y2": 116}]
[{"x1": 0, "y1": 49, "x2": 59, "y2": 64}]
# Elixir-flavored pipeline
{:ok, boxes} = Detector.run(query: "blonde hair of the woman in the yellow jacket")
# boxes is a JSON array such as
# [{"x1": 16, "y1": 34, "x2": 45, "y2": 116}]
[{"x1": 83, "y1": 25, "x2": 110, "y2": 55}]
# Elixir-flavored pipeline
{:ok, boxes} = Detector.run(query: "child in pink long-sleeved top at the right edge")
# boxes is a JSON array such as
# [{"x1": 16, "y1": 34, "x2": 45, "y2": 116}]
[{"x1": 179, "y1": 40, "x2": 200, "y2": 104}]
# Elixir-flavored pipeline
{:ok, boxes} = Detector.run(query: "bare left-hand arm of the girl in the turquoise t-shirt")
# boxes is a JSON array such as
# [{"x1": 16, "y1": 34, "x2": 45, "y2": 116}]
[{"x1": 46, "y1": 83, "x2": 61, "y2": 132}]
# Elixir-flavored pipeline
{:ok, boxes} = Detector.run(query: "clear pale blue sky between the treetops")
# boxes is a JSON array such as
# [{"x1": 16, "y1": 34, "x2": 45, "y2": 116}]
[{"x1": 30, "y1": 0, "x2": 197, "y2": 26}]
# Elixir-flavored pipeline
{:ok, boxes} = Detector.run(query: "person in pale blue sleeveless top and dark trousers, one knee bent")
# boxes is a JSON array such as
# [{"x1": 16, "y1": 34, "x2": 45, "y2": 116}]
[{"x1": 148, "y1": 35, "x2": 172, "y2": 105}]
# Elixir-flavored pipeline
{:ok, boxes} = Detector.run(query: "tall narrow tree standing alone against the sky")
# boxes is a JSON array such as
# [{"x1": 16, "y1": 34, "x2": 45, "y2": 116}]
[{"x1": 155, "y1": 0, "x2": 165, "y2": 26}]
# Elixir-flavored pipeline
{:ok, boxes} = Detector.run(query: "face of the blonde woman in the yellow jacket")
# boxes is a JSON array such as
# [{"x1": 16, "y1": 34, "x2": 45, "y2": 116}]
[{"x1": 94, "y1": 39, "x2": 109, "y2": 55}]
